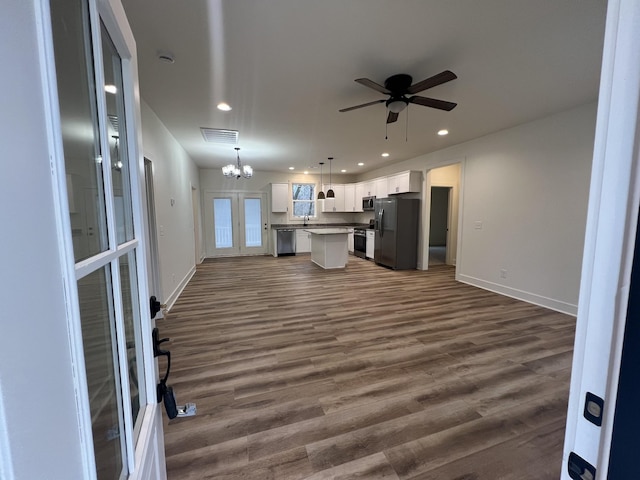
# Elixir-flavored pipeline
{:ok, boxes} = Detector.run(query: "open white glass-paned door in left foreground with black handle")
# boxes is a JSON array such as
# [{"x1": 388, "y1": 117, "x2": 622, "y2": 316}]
[{"x1": 48, "y1": 0, "x2": 166, "y2": 480}]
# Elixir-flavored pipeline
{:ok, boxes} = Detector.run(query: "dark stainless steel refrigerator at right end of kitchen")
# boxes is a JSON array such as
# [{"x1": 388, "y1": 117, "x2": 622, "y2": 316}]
[{"x1": 373, "y1": 197, "x2": 420, "y2": 270}]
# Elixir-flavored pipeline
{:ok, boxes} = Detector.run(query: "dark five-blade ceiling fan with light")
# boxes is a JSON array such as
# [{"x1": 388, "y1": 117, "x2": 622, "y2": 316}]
[{"x1": 338, "y1": 70, "x2": 458, "y2": 123}]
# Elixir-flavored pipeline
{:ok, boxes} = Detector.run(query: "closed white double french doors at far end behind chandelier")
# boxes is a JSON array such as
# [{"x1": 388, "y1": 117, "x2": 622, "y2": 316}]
[{"x1": 204, "y1": 192, "x2": 268, "y2": 257}]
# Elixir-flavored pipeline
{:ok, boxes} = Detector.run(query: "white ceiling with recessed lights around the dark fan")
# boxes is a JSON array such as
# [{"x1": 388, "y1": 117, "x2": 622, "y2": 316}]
[{"x1": 123, "y1": 0, "x2": 606, "y2": 174}]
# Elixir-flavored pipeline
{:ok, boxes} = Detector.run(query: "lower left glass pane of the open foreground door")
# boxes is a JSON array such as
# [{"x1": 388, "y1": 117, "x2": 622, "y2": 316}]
[{"x1": 78, "y1": 265, "x2": 124, "y2": 480}]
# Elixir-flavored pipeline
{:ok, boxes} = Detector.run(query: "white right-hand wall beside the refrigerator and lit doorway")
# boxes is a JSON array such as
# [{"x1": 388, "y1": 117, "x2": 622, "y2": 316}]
[{"x1": 368, "y1": 103, "x2": 596, "y2": 314}]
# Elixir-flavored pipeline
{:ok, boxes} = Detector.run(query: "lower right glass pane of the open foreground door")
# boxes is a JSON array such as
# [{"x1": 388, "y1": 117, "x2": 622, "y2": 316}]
[{"x1": 119, "y1": 250, "x2": 144, "y2": 425}]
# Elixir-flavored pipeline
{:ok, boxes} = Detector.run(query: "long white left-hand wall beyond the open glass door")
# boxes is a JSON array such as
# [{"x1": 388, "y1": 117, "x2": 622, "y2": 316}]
[{"x1": 141, "y1": 101, "x2": 204, "y2": 306}]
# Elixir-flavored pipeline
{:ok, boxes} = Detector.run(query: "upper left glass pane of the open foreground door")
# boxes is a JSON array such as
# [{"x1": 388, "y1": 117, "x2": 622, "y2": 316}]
[{"x1": 50, "y1": 0, "x2": 108, "y2": 261}]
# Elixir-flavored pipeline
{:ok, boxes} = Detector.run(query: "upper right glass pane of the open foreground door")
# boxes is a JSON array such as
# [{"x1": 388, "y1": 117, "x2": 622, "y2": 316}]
[{"x1": 101, "y1": 25, "x2": 133, "y2": 245}]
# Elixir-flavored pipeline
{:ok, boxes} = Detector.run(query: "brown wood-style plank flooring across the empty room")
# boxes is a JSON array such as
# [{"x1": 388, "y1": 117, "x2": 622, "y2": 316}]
[{"x1": 158, "y1": 255, "x2": 575, "y2": 480}]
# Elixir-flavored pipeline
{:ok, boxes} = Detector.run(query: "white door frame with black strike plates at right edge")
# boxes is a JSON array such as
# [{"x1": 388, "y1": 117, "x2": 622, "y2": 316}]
[{"x1": 561, "y1": 0, "x2": 640, "y2": 480}]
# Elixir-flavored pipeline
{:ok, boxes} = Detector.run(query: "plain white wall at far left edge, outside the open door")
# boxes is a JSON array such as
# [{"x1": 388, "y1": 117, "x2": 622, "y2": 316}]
[{"x1": 0, "y1": 0, "x2": 83, "y2": 480}]
